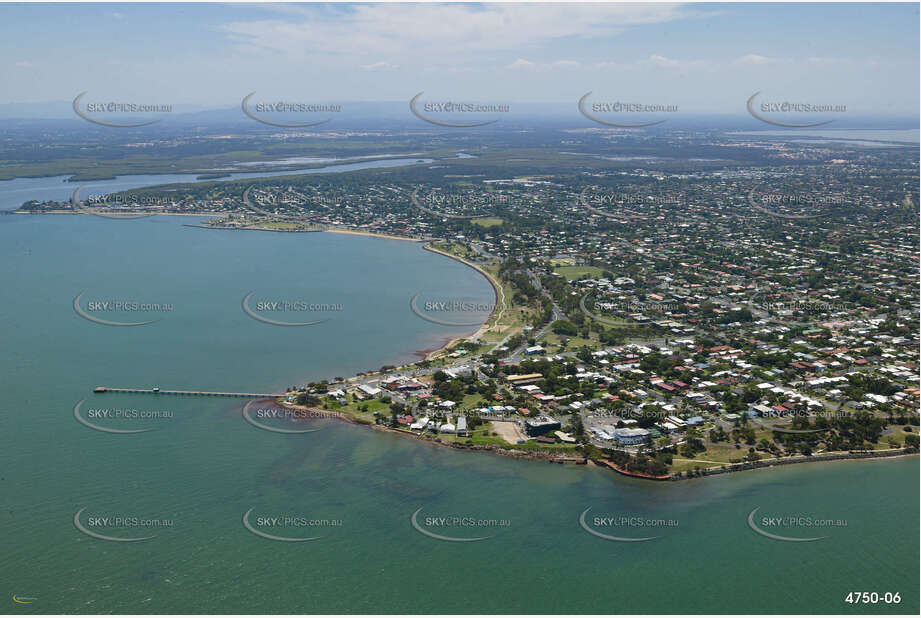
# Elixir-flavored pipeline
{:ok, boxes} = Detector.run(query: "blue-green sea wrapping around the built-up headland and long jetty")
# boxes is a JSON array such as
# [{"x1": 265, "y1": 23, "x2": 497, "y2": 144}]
[{"x1": 0, "y1": 216, "x2": 919, "y2": 613}]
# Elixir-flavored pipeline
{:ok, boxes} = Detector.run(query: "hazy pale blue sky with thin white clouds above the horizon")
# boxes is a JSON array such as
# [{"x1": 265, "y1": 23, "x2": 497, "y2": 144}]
[{"x1": 0, "y1": 3, "x2": 921, "y2": 116}]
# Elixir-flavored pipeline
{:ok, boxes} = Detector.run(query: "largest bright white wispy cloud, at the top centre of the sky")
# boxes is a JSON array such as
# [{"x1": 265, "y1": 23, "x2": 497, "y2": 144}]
[{"x1": 220, "y1": 3, "x2": 691, "y2": 59}]
